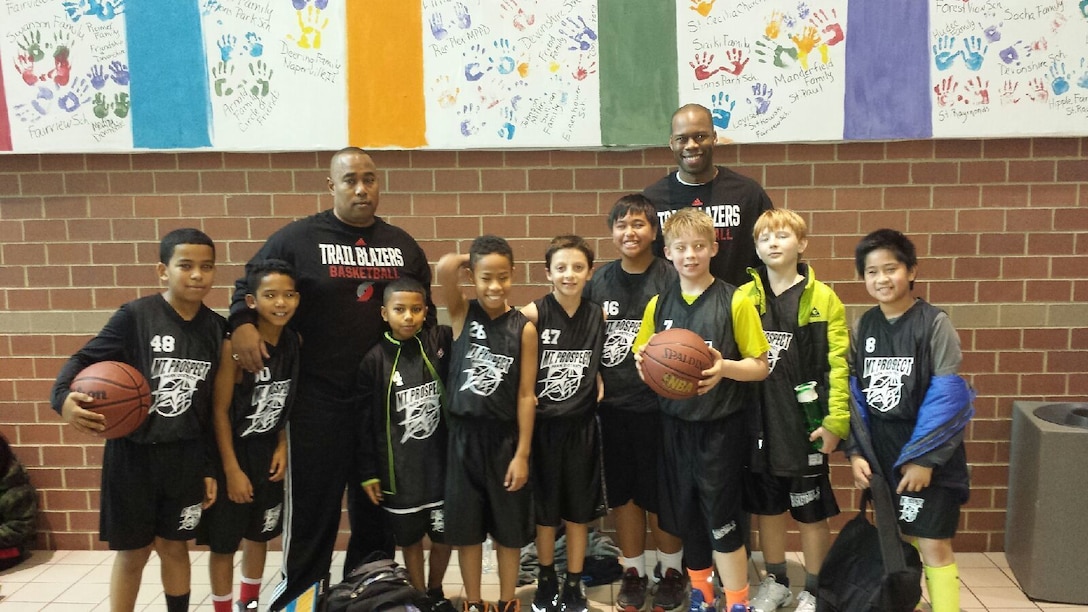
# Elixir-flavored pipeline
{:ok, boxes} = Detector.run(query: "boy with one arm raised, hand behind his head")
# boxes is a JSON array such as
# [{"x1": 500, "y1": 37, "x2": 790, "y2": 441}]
[{"x1": 435, "y1": 235, "x2": 536, "y2": 612}]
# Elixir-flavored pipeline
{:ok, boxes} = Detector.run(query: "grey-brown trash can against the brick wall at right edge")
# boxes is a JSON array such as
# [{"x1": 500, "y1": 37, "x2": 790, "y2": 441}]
[{"x1": 1005, "y1": 402, "x2": 1088, "y2": 604}]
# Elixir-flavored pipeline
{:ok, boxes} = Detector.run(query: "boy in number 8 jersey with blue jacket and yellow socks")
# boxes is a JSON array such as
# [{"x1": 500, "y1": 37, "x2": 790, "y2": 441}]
[{"x1": 844, "y1": 230, "x2": 975, "y2": 612}]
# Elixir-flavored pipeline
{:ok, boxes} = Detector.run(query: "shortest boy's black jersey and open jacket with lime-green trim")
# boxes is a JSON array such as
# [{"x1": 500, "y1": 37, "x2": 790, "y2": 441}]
[{"x1": 359, "y1": 326, "x2": 453, "y2": 510}]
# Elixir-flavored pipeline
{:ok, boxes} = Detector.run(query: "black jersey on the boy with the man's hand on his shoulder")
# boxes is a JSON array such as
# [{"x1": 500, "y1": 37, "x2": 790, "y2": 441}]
[{"x1": 231, "y1": 328, "x2": 299, "y2": 438}]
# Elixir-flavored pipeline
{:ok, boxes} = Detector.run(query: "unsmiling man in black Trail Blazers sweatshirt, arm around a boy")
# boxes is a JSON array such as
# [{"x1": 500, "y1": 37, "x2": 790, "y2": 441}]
[{"x1": 230, "y1": 147, "x2": 435, "y2": 610}]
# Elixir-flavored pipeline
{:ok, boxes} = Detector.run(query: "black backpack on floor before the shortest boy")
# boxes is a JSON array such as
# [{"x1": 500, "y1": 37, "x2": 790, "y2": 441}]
[{"x1": 325, "y1": 552, "x2": 428, "y2": 612}]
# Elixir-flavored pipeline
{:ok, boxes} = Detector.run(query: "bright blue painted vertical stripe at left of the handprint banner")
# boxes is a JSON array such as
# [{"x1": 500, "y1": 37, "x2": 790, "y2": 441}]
[{"x1": 125, "y1": 0, "x2": 211, "y2": 149}]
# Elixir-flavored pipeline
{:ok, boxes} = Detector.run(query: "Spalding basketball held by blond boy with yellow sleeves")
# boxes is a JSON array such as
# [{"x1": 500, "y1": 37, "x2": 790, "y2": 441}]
[{"x1": 642, "y1": 328, "x2": 714, "y2": 400}]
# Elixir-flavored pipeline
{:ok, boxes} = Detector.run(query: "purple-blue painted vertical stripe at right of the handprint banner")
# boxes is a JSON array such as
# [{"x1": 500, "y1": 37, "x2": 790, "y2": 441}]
[{"x1": 842, "y1": 0, "x2": 934, "y2": 140}]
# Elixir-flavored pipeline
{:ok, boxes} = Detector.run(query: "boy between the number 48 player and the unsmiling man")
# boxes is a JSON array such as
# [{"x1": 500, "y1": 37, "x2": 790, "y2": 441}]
[{"x1": 198, "y1": 259, "x2": 299, "y2": 612}]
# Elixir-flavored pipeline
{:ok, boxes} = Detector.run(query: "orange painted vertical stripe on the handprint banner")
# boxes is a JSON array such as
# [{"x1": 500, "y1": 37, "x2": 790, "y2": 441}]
[{"x1": 345, "y1": 0, "x2": 426, "y2": 148}]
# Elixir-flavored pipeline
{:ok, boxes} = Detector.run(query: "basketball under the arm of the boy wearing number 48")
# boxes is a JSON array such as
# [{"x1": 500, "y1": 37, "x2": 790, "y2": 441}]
[{"x1": 69, "y1": 362, "x2": 151, "y2": 438}]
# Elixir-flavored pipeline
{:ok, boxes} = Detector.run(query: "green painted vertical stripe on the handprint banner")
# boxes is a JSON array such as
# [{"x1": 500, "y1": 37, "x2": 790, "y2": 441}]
[{"x1": 597, "y1": 0, "x2": 680, "y2": 146}]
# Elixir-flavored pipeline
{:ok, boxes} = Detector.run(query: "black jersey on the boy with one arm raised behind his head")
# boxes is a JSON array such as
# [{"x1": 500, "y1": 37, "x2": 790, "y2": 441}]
[{"x1": 447, "y1": 299, "x2": 529, "y2": 421}]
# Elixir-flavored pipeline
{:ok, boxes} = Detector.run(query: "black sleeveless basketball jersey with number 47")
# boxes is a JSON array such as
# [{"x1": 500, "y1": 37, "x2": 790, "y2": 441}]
[{"x1": 533, "y1": 293, "x2": 605, "y2": 418}]
